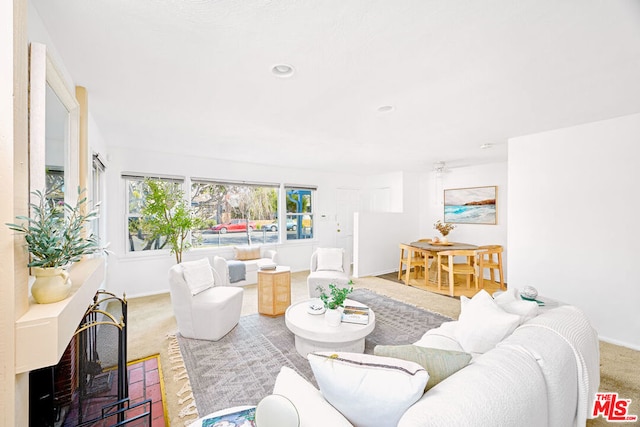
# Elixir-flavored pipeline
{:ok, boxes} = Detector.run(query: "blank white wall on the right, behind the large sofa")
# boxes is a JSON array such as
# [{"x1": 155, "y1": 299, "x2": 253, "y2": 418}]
[{"x1": 508, "y1": 114, "x2": 640, "y2": 349}]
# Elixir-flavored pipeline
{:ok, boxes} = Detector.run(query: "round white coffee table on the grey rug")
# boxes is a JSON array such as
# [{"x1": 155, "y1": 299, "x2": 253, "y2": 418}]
[{"x1": 284, "y1": 299, "x2": 376, "y2": 357}]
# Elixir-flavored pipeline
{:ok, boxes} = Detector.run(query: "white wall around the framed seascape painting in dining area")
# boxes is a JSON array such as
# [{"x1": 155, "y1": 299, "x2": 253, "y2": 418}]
[{"x1": 420, "y1": 162, "x2": 512, "y2": 283}]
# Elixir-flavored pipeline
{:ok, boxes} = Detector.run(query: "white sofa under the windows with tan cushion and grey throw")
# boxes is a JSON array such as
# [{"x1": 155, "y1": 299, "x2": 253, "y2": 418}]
[{"x1": 211, "y1": 246, "x2": 278, "y2": 286}]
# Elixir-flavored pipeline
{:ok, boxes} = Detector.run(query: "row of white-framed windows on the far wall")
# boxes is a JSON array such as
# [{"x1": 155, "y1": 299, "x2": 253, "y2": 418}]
[{"x1": 122, "y1": 173, "x2": 316, "y2": 252}]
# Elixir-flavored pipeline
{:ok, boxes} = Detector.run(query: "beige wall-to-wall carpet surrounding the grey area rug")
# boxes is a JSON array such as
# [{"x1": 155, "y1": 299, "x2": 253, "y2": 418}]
[{"x1": 128, "y1": 272, "x2": 640, "y2": 427}]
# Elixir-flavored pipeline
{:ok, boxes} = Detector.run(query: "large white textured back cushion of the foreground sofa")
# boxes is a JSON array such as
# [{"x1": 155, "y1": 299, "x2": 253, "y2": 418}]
[{"x1": 394, "y1": 346, "x2": 552, "y2": 427}]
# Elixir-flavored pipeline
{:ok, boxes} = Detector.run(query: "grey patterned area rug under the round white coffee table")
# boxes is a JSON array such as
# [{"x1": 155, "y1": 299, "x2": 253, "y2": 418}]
[{"x1": 177, "y1": 289, "x2": 451, "y2": 416}]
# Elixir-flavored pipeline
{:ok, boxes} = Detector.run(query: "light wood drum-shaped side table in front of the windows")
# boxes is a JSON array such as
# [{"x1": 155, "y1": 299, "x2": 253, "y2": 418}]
[{"x1": 258, "y1": 266, "x2": 291, "y2": 316}]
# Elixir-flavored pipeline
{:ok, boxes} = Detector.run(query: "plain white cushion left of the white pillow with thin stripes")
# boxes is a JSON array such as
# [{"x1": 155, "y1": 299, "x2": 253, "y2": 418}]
[{"x1": 273, "y1": 366, "x2": 351, "y2": 427}]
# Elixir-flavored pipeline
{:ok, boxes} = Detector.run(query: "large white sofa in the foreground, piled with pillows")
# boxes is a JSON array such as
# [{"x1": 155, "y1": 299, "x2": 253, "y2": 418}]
[{"x1": 274, "y1": 290, "x2": 600, "y2": 427}]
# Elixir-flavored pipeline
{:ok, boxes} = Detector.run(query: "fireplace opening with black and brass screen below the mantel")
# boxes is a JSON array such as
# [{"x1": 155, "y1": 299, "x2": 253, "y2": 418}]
[{"x1": 29, "y1": 290, "x2": 128, "y2": 427}]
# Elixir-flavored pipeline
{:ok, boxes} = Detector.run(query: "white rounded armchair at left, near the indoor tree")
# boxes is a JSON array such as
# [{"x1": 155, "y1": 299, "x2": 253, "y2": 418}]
[{"x1": 169, "y1": 258, "x2": 243, "y2": 341}]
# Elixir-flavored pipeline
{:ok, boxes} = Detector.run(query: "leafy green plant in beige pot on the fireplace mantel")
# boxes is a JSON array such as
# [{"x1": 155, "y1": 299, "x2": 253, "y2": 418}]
[{"x1": 7, "y1": 190, "x2": 105, "y2": 304}]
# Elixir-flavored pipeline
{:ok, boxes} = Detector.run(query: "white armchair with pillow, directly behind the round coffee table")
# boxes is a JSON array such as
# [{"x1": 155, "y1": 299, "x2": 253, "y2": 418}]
[{"x1": 307, "y1": 248, "x2": 351, "y2": 298}]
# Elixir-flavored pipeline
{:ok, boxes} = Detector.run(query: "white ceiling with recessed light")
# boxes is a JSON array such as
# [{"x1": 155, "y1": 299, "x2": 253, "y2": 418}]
[{"x1": 32, "y1": 0, "x2": 640, "y2": 173}]
